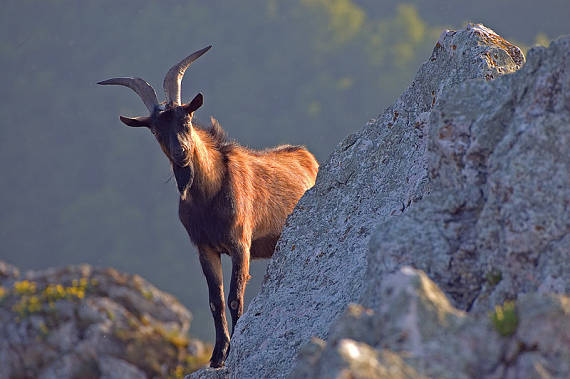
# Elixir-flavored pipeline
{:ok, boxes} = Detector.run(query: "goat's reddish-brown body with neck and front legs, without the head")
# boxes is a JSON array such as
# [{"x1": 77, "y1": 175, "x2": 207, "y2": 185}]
[{"x1": 173, "y1": 119, "x2": 318, "y2": 367}]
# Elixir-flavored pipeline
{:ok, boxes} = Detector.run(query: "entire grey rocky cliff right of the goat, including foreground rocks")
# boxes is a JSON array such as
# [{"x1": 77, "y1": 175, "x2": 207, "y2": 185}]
[{"x1": 194, "y1": 25, "x2": 570, "y2": 378}]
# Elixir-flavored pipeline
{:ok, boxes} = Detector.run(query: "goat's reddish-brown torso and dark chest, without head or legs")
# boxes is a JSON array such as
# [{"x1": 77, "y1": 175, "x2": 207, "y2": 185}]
[{"x1": 179, "y1": 126, "x2": 318, "y2": 258}]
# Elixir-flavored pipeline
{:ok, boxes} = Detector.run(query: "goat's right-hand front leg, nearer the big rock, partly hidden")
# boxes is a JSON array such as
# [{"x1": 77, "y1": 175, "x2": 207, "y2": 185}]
[{"x1": 228, "y1": 242, "x2": 250, "y2": 336}]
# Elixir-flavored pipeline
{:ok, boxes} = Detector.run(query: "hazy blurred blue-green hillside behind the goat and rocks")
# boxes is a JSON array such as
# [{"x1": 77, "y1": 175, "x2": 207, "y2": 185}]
[{"x1": 0, "y1": 0, "x2": 570, "y2": 341}]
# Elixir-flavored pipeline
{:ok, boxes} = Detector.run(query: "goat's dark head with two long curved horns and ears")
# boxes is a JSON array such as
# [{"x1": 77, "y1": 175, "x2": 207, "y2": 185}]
[{"x1": 98, "y1": 46, "x2": 212, "y2": 170}]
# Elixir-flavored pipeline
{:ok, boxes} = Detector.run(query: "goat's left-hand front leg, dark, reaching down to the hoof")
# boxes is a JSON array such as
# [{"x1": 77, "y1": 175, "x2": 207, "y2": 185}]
[{"x1": 199, "y1": 247, "x2": 230, "y2": 367}]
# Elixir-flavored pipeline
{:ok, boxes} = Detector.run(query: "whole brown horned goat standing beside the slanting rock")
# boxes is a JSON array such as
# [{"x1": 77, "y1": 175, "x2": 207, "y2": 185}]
[{"x1": 98, "y1": 46, "x2": 318, "y2": 367}]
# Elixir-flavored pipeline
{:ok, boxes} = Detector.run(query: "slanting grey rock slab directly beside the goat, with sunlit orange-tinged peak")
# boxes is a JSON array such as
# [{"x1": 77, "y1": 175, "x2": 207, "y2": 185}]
[{"x1": 205, "y1": 25, "x2": 524, "y2": 378}]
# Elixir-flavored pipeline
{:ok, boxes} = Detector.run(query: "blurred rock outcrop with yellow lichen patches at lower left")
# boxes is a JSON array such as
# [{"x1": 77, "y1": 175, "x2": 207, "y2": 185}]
[{"x1": 0, "y1": 261, "x2": 211, "y2": 379}]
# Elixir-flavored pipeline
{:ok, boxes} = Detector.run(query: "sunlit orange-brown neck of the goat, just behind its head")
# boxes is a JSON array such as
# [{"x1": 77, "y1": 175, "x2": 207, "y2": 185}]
[{"x1": 185, "y1": 128, "x2": 224, "y2": 199}]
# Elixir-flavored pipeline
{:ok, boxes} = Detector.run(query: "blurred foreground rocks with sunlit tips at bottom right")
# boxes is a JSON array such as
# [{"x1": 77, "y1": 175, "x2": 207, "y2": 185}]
[{"x1": 290, "y1": 267, "x2": 570, "y2": 379}]
